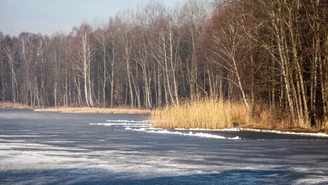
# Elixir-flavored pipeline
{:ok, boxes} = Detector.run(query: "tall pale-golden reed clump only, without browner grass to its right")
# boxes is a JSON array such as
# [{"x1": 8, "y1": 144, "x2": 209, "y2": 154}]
[{"x1": 150, "y1": 99, "x2": 248, "y2": 129}]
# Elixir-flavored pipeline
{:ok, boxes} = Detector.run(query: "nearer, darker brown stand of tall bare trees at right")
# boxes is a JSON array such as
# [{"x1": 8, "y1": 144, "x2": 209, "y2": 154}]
[{"x1": 200, "y1": 0, "x2": 328, "y2": 128}]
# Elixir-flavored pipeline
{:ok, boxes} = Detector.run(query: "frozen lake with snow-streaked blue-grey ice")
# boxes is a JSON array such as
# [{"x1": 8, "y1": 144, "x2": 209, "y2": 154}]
[{"x1": 0, "y1": 109, "x2": 328, "y2": 185}]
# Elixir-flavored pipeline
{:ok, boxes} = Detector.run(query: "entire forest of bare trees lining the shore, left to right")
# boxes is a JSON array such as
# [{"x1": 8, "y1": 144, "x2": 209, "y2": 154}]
[{"x1": 0, "y1": 0, "x2": 328, "y2": 128}]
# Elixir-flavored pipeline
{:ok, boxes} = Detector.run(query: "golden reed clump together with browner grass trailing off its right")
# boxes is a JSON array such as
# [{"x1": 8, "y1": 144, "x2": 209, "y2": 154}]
[{"x1": 150, "y1": 99, "x2": 283, "y2": 129}]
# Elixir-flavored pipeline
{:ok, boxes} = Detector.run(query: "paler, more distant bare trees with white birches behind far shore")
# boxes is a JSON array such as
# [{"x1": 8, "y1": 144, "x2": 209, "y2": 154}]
[{"x1": 0, "y1": 0, "x2": 213, "y2": 108}]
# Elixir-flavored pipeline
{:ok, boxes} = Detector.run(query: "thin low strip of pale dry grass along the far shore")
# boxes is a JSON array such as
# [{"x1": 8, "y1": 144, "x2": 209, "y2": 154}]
[{"x1": 35, "y1": 107, "x2": 150, "y2": 114}]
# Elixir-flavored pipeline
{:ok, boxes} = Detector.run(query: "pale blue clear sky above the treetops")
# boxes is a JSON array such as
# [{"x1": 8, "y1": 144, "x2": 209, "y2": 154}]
[{"x1": 0, "y1": 0, "x2": 185, "y2": 36}]
